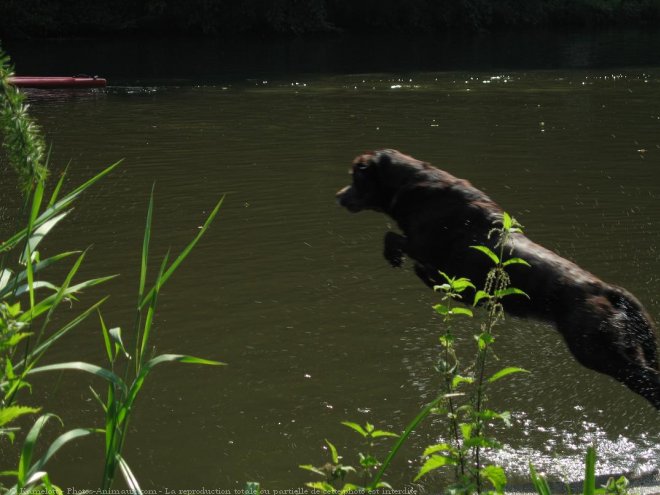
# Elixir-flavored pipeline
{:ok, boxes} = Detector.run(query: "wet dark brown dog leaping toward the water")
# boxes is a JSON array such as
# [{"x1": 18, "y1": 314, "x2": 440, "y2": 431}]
[{"x1": 337, "y1": 150, "x2": 660, "y2": 409}]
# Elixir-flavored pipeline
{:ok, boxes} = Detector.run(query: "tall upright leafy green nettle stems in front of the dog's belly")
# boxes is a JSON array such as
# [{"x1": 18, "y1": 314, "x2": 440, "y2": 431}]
[{"x1": 415, "y1": 212, "x2": 529, "y2": 493}]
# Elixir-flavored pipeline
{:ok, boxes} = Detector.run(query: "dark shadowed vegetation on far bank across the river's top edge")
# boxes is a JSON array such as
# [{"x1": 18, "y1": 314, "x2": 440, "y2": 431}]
[{"x1": 0, "y1": 0, "x2": 660, "y2": 38}]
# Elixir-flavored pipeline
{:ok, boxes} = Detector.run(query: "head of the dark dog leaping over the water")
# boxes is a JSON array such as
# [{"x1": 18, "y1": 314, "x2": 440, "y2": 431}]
[{"x1": 336, "y1": 149, "x2": 429, "y2": 213}]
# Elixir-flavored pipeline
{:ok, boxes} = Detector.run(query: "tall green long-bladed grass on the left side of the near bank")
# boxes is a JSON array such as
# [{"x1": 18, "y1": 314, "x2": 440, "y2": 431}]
[{"x1": 0, "y1": 45, "x2": 223, "y2": 495}]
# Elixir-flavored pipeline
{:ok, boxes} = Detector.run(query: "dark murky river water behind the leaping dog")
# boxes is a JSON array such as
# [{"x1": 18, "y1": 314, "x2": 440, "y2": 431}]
[{"x1": 0, "y1": 33, "x2": 660, "y2": 493}]
